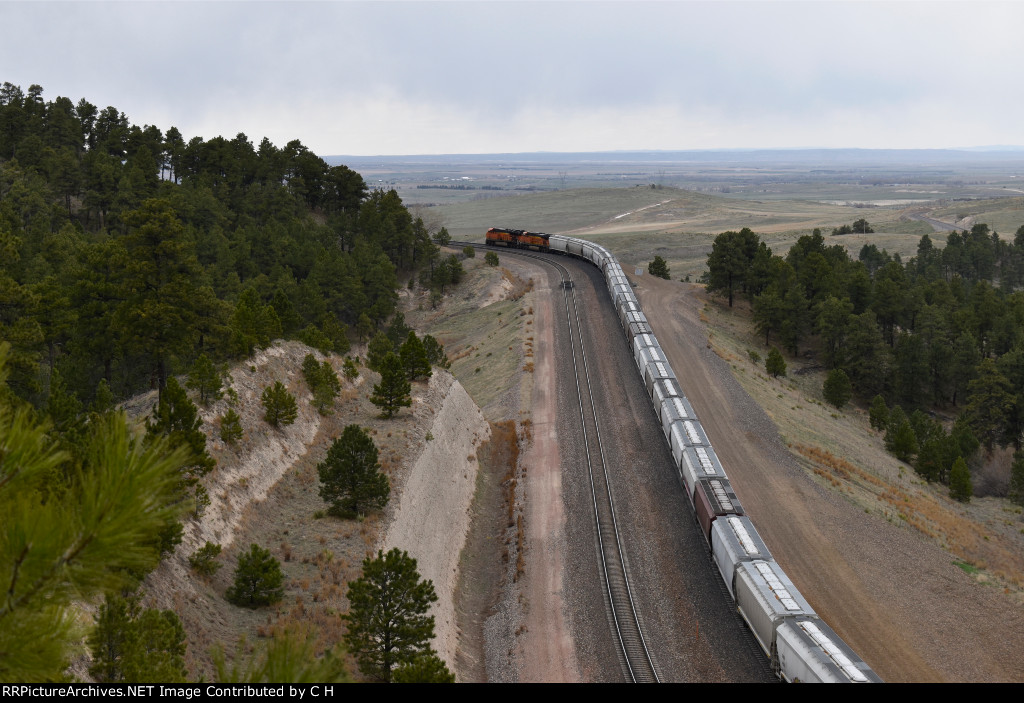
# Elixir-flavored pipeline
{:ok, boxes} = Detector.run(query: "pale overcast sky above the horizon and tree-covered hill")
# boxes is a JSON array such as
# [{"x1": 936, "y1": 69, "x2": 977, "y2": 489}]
[{"x1": 0, "y1": 0, "x2": 1024, "y2": 156}]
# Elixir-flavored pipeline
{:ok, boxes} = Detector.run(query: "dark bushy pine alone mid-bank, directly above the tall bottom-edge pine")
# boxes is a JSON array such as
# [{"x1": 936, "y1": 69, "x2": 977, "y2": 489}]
[{"x1": 316, "y1": 425, "x2": 391, "y2": 517}]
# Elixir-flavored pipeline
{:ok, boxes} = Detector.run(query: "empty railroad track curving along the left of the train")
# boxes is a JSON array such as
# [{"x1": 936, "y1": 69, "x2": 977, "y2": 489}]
[{"x1": 452, "y1": 241, "x2": 660, "y2": 684}]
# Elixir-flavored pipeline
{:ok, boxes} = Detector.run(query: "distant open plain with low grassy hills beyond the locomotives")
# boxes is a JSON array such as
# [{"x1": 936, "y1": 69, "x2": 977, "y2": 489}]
[{"x1": 339, "y1": 149, "x2": 1024, "y2": 279}]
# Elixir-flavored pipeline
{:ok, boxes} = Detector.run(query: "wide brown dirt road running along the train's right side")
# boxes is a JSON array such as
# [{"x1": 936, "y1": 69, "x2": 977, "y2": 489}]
[{"x1": 637, "y1": 276, "x2": 1024, "y2": 682}]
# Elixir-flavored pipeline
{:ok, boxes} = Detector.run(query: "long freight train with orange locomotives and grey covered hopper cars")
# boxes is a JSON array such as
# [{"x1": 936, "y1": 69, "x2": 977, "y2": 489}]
[{"x1": 486, "y1": 228, "x2": 882, "y2": 684}]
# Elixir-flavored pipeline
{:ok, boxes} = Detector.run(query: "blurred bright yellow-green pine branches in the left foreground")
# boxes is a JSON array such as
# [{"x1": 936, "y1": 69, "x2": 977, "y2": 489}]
[{"x1": 0, "y1": 343, "x2": 186, "y2": 682}]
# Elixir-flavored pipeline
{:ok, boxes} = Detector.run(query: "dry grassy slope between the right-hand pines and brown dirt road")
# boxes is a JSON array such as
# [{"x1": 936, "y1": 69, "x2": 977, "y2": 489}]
[{"x1": 701, "y1": 300, "x2": 1024, "y2": 590}]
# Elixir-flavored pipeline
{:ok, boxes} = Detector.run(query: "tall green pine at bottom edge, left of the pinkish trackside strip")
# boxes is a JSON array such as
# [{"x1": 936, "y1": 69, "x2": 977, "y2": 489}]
[{"x1": 343, "y1": 548, "x2": 437, "y2": 682}]
